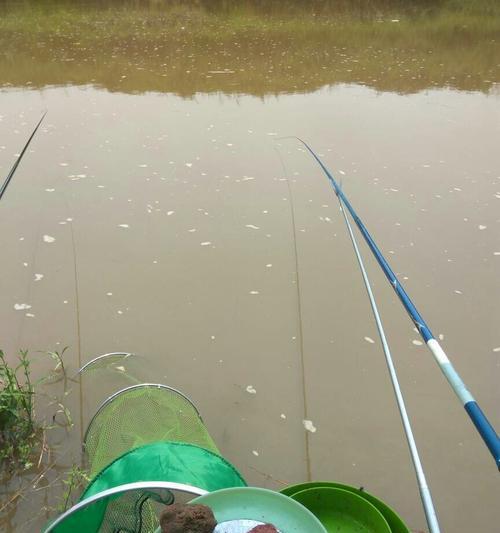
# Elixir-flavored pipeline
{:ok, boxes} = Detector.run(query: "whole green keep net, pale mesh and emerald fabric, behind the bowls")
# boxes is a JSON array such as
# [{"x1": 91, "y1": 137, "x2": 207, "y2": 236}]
[{"x1": 45, "y1": 383, "x2": 246, "y2": 533}]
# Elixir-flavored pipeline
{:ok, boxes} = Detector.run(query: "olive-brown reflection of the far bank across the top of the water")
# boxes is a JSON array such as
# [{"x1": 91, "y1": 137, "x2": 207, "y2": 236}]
[{"x1": 0, "y1": 0, "x2": 500, "y2": 96}]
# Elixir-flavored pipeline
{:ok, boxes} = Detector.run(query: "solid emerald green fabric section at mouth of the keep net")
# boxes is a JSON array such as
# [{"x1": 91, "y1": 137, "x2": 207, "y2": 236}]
[{"x1": 47, "y1": 442, "x2": 246, "y2": 533}]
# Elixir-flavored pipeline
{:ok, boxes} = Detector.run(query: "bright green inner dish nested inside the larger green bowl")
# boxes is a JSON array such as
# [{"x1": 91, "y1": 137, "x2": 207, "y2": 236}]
[{"x1": 291, "y1": 487, "x2": 391, "y2": 533}]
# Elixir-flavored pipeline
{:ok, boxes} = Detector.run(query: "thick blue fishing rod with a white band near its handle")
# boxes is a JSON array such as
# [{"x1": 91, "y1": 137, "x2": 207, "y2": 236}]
[{"x1": 294, "y1": 137, "x2": 500, "y2": 470}]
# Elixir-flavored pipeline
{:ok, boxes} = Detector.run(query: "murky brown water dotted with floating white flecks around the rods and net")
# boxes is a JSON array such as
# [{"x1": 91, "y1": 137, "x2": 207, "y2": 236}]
[{"x1": 0, "y1": 2, "x2": 500, "y2": 533}]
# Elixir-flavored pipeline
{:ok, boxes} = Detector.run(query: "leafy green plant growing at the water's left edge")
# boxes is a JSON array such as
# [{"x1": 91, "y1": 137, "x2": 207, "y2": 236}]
[{"x1": 0, "y1": 350, "x2": 40, "y2": 473}]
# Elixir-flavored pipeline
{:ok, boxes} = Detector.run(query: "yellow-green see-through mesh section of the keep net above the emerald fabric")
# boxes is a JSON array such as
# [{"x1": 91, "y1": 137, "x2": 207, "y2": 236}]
[{"x1": 84, "y1": 384, "x2": 219, "y2": 478}]
